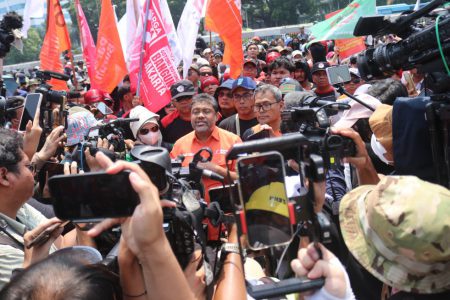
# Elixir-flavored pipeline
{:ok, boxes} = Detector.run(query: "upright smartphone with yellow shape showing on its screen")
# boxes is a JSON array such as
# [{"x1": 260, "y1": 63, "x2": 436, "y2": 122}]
[{"x1": 237, "y1": 151, "x2": 293, "y2": 250}]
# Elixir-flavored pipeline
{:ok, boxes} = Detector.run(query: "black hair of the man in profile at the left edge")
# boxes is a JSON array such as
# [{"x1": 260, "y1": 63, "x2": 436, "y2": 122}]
[{"x1": 0, "y1": 128, "x2": 23, "y2": 173}]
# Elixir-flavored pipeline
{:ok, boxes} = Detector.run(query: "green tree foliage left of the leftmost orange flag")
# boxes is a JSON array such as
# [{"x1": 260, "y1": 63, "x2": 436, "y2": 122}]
[{"x1": 4, "y1": 28, "x2": 43, "y2": 65}]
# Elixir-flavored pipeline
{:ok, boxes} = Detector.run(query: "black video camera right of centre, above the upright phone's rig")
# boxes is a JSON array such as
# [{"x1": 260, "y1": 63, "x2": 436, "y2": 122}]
[{"x1": 281, "y1": 95, "x2": 356, "y2": 169}]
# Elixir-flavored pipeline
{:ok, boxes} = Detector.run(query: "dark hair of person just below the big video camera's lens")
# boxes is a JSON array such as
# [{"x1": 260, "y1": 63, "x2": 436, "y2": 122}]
[{"x1": 367, "y1": 78, "x2": 408, "y2": 105}]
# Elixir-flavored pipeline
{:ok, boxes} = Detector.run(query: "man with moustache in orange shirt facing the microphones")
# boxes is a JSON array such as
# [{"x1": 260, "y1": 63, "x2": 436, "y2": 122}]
[{"x1": 170, "y1": 94, "x2": 242, "y2": 202}]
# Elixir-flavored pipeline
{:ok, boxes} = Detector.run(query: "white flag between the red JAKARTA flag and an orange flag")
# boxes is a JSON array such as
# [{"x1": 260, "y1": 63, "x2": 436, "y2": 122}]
[{"x1": 177, "y1": 0, "x2": 206, "y2": 78}]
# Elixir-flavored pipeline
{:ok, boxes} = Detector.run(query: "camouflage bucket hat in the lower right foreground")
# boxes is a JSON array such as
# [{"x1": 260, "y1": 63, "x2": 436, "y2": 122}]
[{"x1": 339, "y1": 176, "x2": 450, "y2": 294}]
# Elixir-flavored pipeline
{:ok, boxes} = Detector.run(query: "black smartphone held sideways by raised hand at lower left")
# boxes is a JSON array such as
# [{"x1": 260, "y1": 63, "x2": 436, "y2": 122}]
[{"x1": 48, "y1": 171, "x2": 140, "y2": 222}]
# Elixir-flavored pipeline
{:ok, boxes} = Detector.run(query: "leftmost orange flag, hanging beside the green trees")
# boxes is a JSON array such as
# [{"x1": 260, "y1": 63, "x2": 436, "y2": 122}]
[{"x1": 39, "y1": 0, "x2": 71, "y2": 90}]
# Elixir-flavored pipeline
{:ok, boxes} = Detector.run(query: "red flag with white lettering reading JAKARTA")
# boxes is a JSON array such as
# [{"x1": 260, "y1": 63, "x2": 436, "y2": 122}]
[{"x1": 130, "y1": 0, "x2": 180, "y2": 112}]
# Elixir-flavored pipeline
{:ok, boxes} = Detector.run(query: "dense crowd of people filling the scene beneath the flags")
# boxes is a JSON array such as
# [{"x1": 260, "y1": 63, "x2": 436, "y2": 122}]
[{"x1": 0, "y1": 28, "x2": 450, "y2": 299}]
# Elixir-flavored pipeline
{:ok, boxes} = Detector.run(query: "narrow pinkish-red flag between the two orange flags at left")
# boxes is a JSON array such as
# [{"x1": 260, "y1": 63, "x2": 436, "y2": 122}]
[{"x1": 75, "y1": 0, "x2": 97, "y2": 89}]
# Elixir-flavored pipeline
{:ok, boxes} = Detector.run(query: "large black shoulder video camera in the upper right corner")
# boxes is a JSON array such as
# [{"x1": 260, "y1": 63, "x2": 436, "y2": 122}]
[{"x1": 354, "y1": 0, "x2": 450, "y2": 93}]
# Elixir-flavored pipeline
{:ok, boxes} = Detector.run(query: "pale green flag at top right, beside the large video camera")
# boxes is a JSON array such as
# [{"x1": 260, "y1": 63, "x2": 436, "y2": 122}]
[{"x1": 308, "y1": 0, "x2": 376, "y2": 44}]
